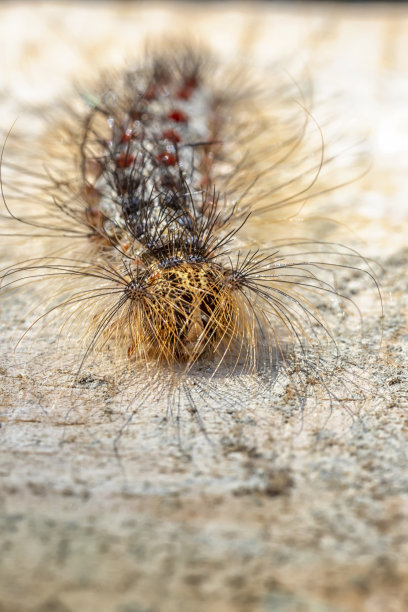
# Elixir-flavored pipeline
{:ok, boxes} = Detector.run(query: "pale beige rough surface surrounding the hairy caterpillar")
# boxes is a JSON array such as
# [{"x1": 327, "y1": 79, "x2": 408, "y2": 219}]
[{"x1": 0, "y1": 3, "x2": 408, "y2": 612}]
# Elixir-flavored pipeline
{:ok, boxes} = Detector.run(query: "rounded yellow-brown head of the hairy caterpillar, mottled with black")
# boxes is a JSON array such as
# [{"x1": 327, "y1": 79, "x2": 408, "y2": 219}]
[{"x1": 126, "y1": 257, "x2": 238, "y2": 363}]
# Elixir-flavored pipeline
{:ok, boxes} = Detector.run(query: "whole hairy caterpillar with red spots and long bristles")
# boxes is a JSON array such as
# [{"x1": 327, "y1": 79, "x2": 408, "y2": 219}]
[{"x1": 1, "y1": 45, "x2": 380, "y2": 438}]
